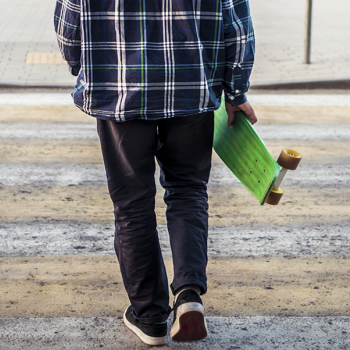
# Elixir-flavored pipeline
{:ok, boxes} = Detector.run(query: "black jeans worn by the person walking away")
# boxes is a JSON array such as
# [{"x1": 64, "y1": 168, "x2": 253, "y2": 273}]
[{"x1": 97, "y1": 112, "x2": 214, "y2": 323}]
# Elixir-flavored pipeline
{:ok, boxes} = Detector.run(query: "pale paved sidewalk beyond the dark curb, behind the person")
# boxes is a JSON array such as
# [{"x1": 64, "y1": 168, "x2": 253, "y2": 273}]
[{"x1": 0, "y1": 0, "x2": 350, "y2": 87}]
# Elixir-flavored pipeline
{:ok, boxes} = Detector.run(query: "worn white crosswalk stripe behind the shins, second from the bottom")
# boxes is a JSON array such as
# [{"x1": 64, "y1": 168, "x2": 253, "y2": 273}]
[{"x1": 0, "y1": 221, "x2": 350, "y2": 259}]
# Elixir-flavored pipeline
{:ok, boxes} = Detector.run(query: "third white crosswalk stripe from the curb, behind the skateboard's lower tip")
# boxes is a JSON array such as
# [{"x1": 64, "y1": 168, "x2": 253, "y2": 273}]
[{"x1": 0, "y1": 163, "x2": 350, "y2": 187}]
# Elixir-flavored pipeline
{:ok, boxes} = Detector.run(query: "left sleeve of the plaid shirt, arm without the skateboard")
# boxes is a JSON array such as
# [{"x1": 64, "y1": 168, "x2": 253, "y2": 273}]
[{"x1": 54, "y1": 0, "x2": 81, "y2": 76}]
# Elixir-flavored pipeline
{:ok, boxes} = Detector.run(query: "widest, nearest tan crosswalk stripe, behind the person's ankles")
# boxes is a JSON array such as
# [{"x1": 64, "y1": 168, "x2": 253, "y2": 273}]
[{"x1": 0, "y1": 254, "x2": 350, "y2": 317}]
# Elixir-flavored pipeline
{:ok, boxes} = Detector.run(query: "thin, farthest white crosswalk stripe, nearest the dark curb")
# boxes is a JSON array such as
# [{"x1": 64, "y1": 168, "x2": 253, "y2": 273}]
[{"x1": 0, "y1": 92, "x2": 350, "y2": 107}]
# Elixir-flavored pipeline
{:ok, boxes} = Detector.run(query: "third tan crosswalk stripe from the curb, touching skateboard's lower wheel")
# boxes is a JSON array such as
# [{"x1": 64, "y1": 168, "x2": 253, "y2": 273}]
[{"x1": 0, "y1": 183, "x2": 350, "y2": 225}]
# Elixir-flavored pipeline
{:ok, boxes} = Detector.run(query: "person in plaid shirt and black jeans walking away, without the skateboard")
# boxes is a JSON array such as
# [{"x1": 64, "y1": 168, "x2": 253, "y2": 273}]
[{"x1": 54, "y1": 0, "x2": 257, "y2": 345}]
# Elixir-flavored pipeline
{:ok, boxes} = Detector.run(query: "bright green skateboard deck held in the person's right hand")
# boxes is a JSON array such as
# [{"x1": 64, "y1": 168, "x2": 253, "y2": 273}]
[{"x1": 213, "y1": 101, "x2": 280, "y2": 205}]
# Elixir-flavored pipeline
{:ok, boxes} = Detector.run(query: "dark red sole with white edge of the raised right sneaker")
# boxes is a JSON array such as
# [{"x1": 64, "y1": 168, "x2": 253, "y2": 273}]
[{"x1": 170, "y1": 303, "x2": 208, "y2": 341}]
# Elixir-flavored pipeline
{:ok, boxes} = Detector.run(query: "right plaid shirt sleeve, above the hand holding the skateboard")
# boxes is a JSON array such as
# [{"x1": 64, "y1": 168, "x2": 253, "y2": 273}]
[{"x1": 222, "y1": 0, "x2": 255, "y2": 106}]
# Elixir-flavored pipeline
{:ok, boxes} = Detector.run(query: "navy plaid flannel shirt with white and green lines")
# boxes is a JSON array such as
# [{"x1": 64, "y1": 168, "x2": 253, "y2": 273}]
[{"x1": 54, "y1": 0, "x2": 254, "y2": 121}]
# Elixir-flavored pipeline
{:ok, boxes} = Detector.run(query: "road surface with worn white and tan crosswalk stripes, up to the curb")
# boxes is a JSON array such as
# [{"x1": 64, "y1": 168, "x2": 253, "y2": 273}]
[{"x1": 0, "y1": 91, "x2": 350, "y2": 350}]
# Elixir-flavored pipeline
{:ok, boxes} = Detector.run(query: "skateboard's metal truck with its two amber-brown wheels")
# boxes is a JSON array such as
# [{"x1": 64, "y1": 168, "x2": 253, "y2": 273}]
[{"x1": 266, "y1": 148, "x2": 301, "y2": 205}]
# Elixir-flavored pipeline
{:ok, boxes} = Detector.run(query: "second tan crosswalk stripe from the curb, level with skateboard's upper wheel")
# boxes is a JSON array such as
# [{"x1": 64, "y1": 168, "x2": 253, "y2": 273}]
[{"x1": 0, "y1": 137, "x2": 350, "y2": 165}]
